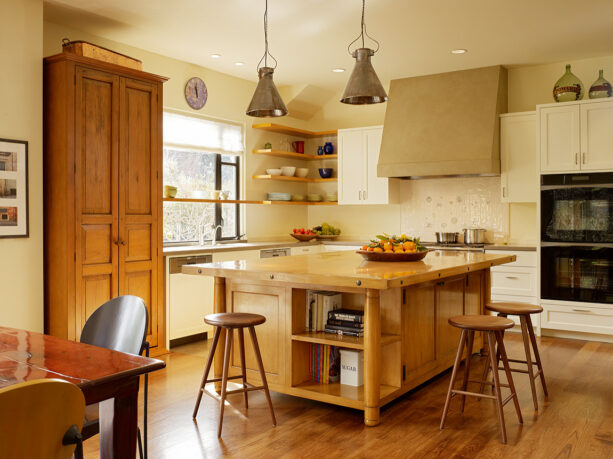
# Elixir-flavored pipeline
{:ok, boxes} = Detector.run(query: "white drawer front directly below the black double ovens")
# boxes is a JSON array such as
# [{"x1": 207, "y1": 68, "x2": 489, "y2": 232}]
[{"x1": 541, "y1": 304, "x2": 613, "y2": 335}]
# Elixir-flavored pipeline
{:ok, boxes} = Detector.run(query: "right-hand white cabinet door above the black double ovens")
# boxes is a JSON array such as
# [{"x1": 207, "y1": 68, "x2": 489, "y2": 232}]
[{"x1": 581, "y1": 102, "x2": 613, "y2": 170}]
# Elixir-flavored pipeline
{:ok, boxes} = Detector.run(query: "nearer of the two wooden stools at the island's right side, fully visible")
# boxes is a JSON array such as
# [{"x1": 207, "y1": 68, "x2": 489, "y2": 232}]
[{"x1": 441, "y1": 315, "x2": 523, "y2": 443}]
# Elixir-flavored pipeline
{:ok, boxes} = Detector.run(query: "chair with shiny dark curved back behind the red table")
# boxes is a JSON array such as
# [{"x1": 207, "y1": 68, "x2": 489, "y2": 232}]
[{"x1": 81, "y1": 295, "x2": 149, "y2": 459}]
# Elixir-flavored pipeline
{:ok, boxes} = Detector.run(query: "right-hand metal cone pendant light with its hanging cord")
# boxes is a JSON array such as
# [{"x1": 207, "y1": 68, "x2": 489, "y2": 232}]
[{"x1": 341, "y1": 0, "x2": 387, "y2": 105}]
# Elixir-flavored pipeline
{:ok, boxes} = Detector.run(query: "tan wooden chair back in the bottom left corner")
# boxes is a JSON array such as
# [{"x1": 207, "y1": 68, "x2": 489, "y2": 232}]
[{"x1": 0, "y1": 379, "x2": 85, "y2": 459}]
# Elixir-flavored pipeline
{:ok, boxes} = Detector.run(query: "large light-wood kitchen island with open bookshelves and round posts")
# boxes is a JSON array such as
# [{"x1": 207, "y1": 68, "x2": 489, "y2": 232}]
[{"x1": 183, "y1": 251, "x2": 515, "y2": 426}]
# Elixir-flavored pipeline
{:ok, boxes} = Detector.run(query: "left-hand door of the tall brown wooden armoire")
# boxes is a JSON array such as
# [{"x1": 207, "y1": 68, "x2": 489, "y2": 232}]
[{"x1": 73, "y1": 68, "x2": 119, "y2": 339}]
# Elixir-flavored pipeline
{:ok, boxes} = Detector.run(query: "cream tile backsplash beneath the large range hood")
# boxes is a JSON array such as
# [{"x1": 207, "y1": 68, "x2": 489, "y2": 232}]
[{"x1": 400, "y1": 177, "x2": 509, "y2": 242}]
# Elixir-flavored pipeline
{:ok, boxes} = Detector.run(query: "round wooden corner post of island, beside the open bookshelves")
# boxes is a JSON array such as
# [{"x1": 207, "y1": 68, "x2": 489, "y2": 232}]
[{"x1": 364, "y1": 289, "x2": 381, "y2": 426}]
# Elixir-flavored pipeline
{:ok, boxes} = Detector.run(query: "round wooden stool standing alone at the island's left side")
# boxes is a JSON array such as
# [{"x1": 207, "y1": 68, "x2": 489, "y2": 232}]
[{"x1": 192, "y1": 312, "x2": 277, "y2": 437}]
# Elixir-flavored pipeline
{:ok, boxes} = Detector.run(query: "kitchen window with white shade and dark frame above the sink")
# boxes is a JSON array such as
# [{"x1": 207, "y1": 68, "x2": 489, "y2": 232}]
[{"x1": 163, "y1": 112, "x2": 244, "y2": 243}]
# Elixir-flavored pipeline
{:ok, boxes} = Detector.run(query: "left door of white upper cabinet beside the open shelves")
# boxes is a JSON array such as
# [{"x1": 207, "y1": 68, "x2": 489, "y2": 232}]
[{"x1": 338, "y1": 129, "x2": 366, "y2": 204}]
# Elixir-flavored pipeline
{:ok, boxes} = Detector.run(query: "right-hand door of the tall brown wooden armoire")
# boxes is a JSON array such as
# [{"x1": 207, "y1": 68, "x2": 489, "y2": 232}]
[{"x1": 119, "y1": 78, "x2": 161, "y2": 346}]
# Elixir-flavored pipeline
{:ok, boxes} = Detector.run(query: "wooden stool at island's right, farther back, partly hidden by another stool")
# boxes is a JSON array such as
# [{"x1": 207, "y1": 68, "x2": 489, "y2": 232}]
[{"x1": 481, "y1": 302, "x2": 549, "y2": 410}]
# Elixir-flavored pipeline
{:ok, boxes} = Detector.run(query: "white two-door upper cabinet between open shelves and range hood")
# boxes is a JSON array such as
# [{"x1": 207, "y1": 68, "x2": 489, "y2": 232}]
[{"x1": 338, "y1": 126, "x2": 396, "y2": 204}]
